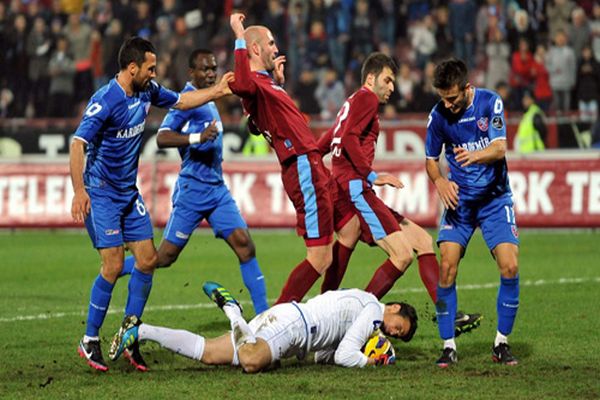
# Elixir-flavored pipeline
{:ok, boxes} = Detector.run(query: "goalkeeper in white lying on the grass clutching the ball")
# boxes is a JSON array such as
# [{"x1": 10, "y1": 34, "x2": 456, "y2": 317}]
[{"x1": 109, "y1": 282, "x2": 417, "y2": 373}]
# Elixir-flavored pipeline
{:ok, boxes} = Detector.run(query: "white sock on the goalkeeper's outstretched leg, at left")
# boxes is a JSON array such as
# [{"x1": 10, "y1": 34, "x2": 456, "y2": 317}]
[{"x1": 138, "y1": 324, "x2": 205, "y2": 360}]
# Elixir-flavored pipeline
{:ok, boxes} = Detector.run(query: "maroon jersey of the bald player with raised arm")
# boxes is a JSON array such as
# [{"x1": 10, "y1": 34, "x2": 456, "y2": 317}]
[{"x1": 229, "y1": 48, "x2": 317, "y2": 163}]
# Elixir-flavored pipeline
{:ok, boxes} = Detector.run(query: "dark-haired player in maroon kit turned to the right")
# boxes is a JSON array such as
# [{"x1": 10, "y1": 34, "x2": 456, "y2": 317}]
[{"x1": 319, "y1": 53, "x2": 481, "y2": 335}]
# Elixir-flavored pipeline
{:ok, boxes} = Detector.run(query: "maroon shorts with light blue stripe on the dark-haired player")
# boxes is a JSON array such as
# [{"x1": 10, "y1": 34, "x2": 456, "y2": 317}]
[{"x1": 332, "y1": 179, "x2": 404, "y2": 246}]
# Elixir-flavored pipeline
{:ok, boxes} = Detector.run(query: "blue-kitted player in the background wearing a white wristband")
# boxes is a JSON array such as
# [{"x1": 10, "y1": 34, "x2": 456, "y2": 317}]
[{"x1": 117, "y1": 49, "x2": 269, "y2": 314}]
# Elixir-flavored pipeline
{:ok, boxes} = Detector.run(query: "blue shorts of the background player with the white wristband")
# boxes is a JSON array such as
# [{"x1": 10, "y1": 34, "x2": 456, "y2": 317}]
[{"x1": 164, "y1": 178, "x2": 248, "y2": 248}]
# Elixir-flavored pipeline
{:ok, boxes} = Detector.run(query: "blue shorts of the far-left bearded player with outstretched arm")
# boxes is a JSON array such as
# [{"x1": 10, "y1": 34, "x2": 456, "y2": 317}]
[{"x1": 85, "y1": 187, "x2": 153, "y2": 249}]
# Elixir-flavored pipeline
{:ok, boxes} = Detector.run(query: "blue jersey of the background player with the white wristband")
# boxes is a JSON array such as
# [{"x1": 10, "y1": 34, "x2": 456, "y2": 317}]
[{"x1": 159, "y1": 82, "x2": 223, "y2": 184}]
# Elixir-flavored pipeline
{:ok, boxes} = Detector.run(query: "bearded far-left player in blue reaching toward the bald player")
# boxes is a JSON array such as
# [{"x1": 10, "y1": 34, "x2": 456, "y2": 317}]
[{"x1": 70, "y1": 37, "x2": 233, "y2": 371}]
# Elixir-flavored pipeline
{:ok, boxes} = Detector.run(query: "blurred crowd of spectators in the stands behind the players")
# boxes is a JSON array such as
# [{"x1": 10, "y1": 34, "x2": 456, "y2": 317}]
[{"x1": 0, "y1": 0, "x2": 600, "y2": 119}]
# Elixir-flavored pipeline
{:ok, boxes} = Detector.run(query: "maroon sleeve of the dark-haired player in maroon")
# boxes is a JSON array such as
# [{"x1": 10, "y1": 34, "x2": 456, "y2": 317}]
[{"x1": 340, "y1": 92, "x2": 379, "y2": 179}]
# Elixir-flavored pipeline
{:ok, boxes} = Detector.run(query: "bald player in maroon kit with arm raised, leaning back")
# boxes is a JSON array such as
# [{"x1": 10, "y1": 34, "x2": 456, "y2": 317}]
[{"x1": 230, "y1": 14, "x2": 333, "y2": 304}]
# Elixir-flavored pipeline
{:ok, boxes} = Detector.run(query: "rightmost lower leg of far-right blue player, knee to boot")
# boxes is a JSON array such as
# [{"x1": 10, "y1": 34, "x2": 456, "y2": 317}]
[{"x1": 492, "y1": 243, "x2": 519, "y2": 365}]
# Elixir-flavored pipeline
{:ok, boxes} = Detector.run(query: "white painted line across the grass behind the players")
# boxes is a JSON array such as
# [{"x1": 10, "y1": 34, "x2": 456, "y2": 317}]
[{"x1": 0, "y1": 277, "x2": 600, "y2": 322}]
